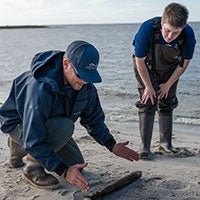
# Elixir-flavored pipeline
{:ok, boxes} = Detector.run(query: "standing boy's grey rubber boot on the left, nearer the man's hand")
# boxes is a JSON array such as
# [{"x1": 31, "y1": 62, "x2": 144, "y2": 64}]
[{"x1": 139, "y1": 112, "x2": 155, "y2": 160}]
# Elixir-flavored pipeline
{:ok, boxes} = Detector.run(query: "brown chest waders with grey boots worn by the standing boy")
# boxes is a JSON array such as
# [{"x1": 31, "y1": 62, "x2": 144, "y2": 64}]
[{"x1": 133, "y1": 19, "x2": 185, "y2": 155}]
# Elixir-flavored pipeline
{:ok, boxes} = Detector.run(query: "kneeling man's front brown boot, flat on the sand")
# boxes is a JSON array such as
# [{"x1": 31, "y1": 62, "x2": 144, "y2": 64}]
[{"x1": 23, "y1": 157, "x2": 59, "y2": 189}]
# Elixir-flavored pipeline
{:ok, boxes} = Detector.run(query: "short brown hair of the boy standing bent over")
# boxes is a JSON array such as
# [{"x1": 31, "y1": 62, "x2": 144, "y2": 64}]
[{"x1": 162, "y1": 3, "x2": 189, "y2": 28}]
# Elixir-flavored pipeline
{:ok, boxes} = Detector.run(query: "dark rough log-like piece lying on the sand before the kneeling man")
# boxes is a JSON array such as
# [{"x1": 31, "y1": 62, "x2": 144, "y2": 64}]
[{"x1": 85, "y1": 171, "x2": 142, "y2": 200}]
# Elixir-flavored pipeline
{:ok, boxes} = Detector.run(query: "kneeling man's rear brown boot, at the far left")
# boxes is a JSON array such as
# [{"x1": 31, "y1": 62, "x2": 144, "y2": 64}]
[{"x1": 8, "y1": 136, "x2": 27, "y2": 168}]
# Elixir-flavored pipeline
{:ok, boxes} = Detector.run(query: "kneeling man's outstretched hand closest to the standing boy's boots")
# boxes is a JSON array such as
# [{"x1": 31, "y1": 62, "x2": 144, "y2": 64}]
[{"x1": 112, "y1": 141, "x2": 139, "y2": 161}]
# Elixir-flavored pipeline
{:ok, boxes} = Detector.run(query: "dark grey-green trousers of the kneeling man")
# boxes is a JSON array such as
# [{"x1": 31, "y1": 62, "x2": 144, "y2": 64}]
[{"x1": 9, "y1": 117, "x2": 84, "y2": 166}]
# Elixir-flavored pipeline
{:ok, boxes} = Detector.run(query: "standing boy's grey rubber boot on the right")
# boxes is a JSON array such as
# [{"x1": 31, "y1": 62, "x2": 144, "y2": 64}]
[{"x1": 158, "y1": 112, "x2": 174, "y2": 153}]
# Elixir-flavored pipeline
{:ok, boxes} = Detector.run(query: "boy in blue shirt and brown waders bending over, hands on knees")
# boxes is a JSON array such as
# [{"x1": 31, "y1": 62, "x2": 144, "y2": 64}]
[{"x1": 133, "y1": 3, "x2": 196, "y2": 159}]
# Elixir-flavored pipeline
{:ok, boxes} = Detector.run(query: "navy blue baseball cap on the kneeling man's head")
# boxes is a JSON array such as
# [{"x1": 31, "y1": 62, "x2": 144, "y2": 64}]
[{"x1": 66, "y1": 40, "x2": 102, "y2": 83}]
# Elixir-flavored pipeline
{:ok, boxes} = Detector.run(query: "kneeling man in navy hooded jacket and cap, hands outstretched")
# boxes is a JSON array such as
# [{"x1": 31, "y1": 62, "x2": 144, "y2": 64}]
[{"x1": 0, "y1": 41, "x2": 138, "y2": 191}]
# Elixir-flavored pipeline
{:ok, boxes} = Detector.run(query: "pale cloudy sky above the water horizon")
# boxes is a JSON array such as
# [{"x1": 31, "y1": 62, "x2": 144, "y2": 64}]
[{"x1": 0, "y1": 0, "x2": 200, "y2": 26}]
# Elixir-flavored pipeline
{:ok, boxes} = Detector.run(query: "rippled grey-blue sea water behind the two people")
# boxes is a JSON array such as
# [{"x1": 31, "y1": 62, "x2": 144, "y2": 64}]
[{"x1": 0, "y1": 22, "x2": 200, "y2": 125}]
